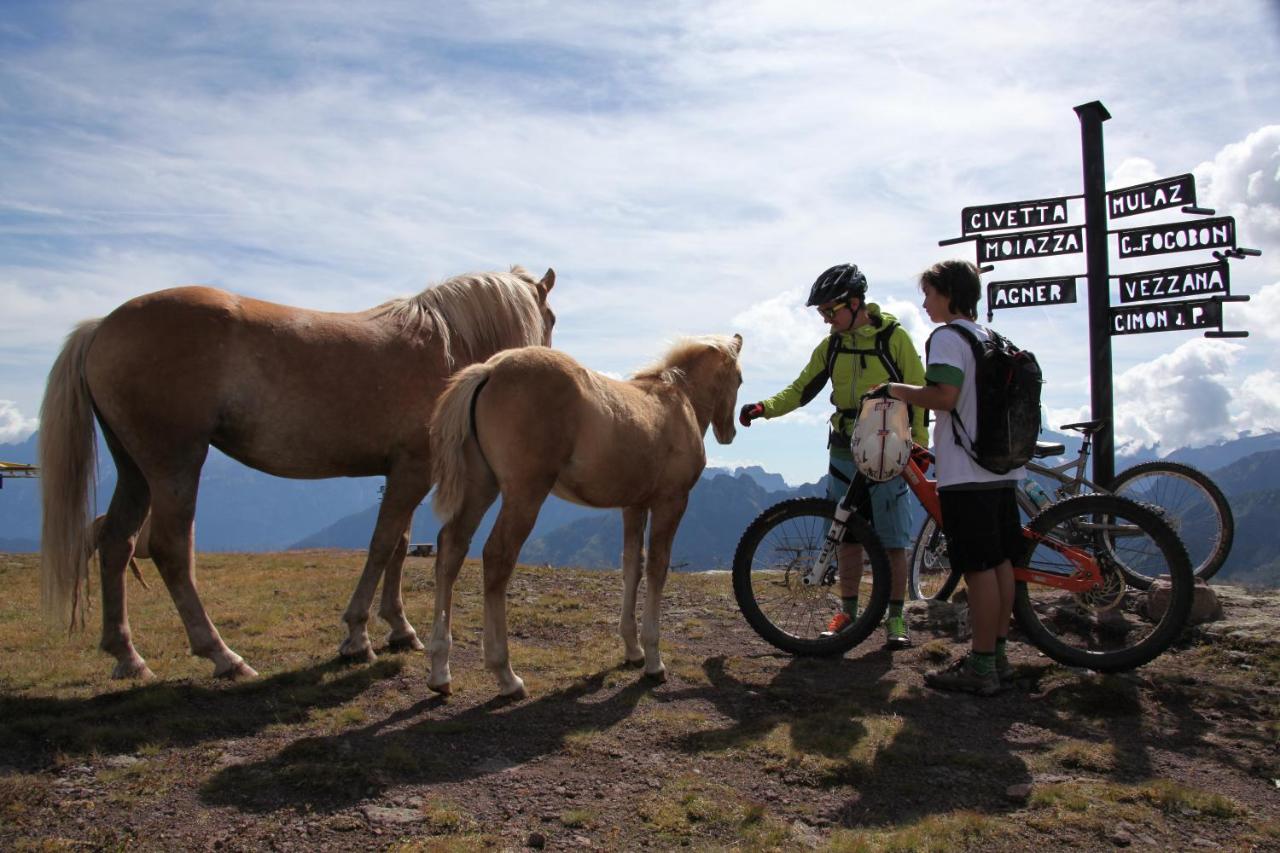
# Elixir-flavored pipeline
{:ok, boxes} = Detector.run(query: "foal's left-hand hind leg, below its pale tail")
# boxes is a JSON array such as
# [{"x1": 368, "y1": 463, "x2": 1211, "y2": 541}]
[{"x1": 426, "y1": 443, "x2": 498, "y2": 695}]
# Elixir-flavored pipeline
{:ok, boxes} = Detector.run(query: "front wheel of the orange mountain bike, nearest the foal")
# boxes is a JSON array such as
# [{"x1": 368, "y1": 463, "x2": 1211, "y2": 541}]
[{"x1": 733, "y1": 498, "x2": 890, "y2": 654}]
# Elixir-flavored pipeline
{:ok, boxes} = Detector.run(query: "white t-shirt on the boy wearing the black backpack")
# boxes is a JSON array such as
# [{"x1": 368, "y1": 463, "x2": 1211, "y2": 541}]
[{"x1": 924, "y1": 319, "x2": 1027, "y2": 489}]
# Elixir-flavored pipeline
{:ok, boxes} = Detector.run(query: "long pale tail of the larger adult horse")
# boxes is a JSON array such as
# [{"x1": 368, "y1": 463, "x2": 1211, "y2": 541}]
[{"x1": 40, "y1": 320, "x2": 102, "y2": 629}]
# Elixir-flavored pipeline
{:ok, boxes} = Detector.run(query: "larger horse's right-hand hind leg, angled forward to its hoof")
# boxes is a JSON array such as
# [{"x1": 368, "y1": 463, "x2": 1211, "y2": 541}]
[{"x1": 146, "y1": 484, "x2": 257, "y2": 679}]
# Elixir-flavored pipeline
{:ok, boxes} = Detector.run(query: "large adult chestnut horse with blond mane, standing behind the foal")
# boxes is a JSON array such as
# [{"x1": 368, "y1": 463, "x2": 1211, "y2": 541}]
[{"x1": 40, "y1": 266, "x2": 556, "y2": 678}]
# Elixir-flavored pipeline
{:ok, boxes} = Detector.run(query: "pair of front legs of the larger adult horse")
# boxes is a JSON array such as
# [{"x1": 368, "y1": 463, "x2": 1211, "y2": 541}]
[{"x1": 338, "y1": 468, "x2": 430, "y2": 662}]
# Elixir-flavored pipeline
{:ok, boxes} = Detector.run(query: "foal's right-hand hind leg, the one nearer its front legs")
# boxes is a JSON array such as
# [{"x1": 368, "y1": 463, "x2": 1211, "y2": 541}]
[{"x1": 484, "y1": 480, "x2": 554, "y2": 699}]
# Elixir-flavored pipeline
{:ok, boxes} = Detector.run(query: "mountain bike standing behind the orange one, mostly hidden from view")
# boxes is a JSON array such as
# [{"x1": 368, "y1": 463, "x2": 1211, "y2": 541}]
[{"x1": 909, "y1": 420, "x2": 1235, "y2": 601}]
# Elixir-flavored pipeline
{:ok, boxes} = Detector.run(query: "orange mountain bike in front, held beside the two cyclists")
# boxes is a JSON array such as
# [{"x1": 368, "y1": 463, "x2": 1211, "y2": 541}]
[{"x1": 733, "y1": 446, "x2": 1196, "y2": 672}]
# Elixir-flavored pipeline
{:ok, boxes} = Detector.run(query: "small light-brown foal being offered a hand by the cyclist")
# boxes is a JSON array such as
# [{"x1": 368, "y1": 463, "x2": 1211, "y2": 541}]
[{"x1": 428, "y1": 336, "x2": 742, "y2": 697}]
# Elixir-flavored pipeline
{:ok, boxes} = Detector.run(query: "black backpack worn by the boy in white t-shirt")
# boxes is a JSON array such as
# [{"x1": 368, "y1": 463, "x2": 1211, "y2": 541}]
[{"x1": 924, "y1": 323, "x2": 1044, "y2": 474}]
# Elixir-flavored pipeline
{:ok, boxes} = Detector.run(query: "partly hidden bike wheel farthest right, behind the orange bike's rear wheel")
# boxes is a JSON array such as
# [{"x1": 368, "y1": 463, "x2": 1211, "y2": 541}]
[{"x1": 1111, "y1": 462, "x2": 1235, "y2": 580}]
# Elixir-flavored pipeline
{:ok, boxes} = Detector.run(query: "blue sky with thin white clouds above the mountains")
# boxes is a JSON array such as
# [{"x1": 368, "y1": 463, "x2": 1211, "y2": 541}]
[{"x1": 0, "y1": 0, "x2": 1280, "y2": 482}]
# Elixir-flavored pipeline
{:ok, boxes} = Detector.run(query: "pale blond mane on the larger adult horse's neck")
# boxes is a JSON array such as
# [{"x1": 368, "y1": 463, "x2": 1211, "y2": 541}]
[{"x1": 369, "y1": 265, "x2": 543, "y2": 368}]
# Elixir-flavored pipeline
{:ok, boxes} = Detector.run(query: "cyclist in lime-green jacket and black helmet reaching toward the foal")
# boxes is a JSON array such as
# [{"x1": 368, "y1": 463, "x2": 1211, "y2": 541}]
[{"x1": 739, "y1": 264, "x2": 929, "y2": 648}]
